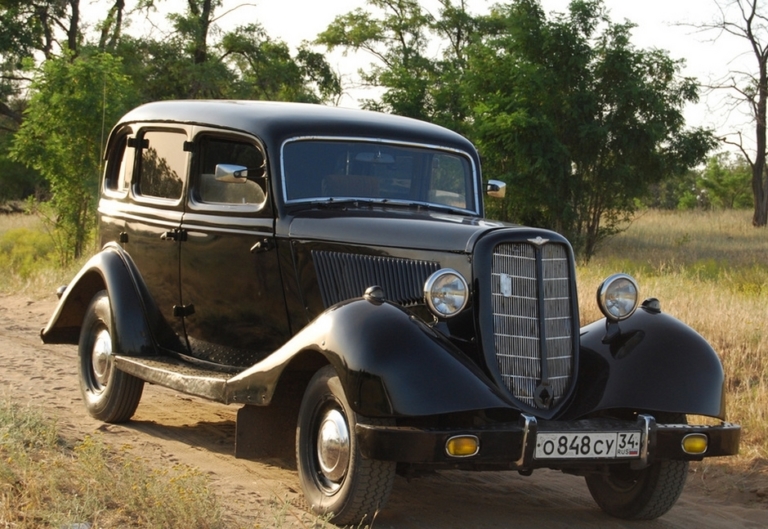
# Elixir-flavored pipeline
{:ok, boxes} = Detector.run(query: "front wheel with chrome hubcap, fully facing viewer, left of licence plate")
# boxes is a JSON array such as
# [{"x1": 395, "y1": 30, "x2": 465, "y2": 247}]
[{"x1": 296, "y1": 366, "x2": 396, "y2": 527}]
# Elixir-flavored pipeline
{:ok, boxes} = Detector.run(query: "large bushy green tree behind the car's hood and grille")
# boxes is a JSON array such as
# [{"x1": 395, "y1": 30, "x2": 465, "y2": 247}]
[{"x1": 468, "y1": 0, "x2": 712, "y2": 259}]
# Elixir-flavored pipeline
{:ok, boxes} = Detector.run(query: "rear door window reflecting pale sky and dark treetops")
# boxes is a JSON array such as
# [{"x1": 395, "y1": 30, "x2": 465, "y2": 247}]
[{"x1": 137, "y1": 131, "x2": 188, "y2": 200}]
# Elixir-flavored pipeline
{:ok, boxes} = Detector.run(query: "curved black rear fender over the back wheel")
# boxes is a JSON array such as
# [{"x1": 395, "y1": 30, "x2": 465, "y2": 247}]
[{"x1": 40, "y1": 244, "x2": 176, "y2": 356}]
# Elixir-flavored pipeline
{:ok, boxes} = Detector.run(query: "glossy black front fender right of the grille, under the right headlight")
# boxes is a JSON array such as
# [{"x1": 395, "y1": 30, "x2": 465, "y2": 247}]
[{"x1": 563, "y1": 307, "x2": 725, "y2": 419}]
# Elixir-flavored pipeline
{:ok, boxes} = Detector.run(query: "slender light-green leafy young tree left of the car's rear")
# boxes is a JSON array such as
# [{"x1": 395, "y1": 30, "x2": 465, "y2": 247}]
[{"x1": 13, "y1": 53, "x2": 136, "y2": 263}]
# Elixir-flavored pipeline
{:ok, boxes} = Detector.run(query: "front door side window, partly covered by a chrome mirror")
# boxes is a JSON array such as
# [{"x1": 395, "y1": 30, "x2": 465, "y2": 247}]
[{"x1": 194, "y1": 136, "x2": 266, "y2": 206}]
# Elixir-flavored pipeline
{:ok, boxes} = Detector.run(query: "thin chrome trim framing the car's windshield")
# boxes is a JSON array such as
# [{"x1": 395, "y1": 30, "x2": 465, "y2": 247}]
[{"x1": 280, "y1": 136, "x2": 481, "y2": 215}]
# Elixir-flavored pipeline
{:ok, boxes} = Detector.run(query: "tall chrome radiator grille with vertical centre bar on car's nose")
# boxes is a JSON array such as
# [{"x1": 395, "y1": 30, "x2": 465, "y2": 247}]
[{"x1": 491, "y1": 243, "x2": 574, "y2": 408}]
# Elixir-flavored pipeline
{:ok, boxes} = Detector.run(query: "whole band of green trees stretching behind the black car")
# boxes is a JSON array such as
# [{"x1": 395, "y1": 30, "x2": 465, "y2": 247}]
[{"x1": 0, "y1": 0, "x2": 749, "y2": 263}]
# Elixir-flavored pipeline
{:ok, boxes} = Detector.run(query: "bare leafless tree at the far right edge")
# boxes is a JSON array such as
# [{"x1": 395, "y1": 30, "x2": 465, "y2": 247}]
[{"x1": 699, "y1": 0, "x2": 768, "y2": 227}]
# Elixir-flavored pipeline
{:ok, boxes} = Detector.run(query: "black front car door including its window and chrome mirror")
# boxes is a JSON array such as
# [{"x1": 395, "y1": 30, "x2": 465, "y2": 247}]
[{"x1": 180, "y1": 129, "x2": 290, "y2": 367}]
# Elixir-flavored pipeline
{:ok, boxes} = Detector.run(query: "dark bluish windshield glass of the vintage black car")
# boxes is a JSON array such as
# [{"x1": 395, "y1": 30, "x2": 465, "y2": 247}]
[{"x1": 283, "y1": 139, "x2": 477, "y2": 213}]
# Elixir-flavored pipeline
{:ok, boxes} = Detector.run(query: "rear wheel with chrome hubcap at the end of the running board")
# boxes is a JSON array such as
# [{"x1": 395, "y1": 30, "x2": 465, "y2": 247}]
[{"x1": 78, "y1": 290, "x2": 144, "y2": 423}]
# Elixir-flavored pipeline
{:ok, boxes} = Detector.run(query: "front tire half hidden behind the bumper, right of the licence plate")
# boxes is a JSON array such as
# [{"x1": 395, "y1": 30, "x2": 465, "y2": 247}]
[{"x1": 586, "y1": 415, "x2": 688, "y2": 520}]
